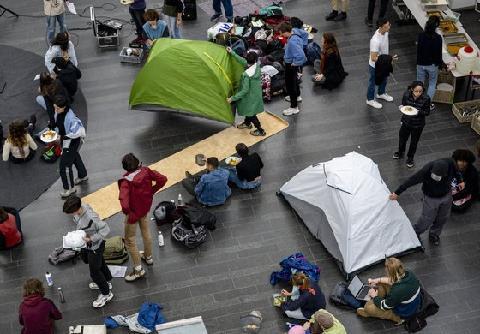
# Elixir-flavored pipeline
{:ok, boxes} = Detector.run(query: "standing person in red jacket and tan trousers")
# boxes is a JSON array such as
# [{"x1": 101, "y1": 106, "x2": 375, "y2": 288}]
[{"x1": 118, "y1": 153, "x2": 167, "y2": 282}]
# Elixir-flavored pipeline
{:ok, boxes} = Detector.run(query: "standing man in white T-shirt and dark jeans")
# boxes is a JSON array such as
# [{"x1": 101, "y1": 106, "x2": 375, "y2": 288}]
[{"x1": 367, "y1": 19, "x2": 396, "y2": 109}]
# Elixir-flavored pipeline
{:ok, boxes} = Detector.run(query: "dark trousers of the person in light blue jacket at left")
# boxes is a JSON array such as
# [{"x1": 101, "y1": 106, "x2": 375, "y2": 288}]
[{"x1": 59, "y1": 138, "x2": 87, "y2": 189}]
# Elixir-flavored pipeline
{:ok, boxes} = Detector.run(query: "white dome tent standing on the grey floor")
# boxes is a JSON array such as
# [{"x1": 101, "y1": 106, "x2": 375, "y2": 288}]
[{"x1": 280, "y1": 152, "x2": 421, "y2": 278}]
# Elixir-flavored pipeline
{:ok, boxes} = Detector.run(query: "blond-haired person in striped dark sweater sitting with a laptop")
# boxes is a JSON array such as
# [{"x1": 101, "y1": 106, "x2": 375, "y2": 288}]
[{"x1": 357, "y1": 257, "x2": 422, "y2": 325}]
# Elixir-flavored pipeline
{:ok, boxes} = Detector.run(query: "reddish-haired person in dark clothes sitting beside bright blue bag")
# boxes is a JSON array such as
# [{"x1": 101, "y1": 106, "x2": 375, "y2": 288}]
[{"x1": 281, "y1": 273, "x2": 326, "y2": 320}]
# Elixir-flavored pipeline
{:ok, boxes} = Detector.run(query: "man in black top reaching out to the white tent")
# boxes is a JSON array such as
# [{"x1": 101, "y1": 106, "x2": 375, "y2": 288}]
[{"x1": 389, "y1": 158, "x2": 465, "y2": 246}]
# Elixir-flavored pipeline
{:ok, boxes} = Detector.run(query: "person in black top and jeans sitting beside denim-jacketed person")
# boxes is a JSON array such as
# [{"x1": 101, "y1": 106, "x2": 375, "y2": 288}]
[{"x1": 228, "y1": 143, "x2": 263, "y2": 189}]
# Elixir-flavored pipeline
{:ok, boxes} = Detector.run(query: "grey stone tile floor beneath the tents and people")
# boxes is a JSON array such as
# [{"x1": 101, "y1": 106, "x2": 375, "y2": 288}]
[{"x1": 0, "y1": 0, "x2": 480, "y2": 334}]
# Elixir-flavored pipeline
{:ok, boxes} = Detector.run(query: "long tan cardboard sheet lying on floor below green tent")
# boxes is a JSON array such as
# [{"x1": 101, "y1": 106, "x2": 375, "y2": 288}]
[{"x1": 82, "y1": 112, "x2": 288, "y2": 219}]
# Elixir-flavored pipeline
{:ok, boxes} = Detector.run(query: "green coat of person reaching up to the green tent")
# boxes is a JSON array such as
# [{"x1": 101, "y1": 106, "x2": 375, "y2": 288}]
[{"x1": 231, "y1": 51, "x2": 263, "y2": 116}]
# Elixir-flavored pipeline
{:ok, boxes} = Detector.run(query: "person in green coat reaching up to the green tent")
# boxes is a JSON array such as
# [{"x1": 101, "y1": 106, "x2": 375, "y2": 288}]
[{"x1": 227, "y1": 47, "x2": 267, "y2": 136}]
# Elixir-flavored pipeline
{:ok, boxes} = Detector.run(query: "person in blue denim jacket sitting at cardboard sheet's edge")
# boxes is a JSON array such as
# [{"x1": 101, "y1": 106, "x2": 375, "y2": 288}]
[{"x1": 182, "y1": 158, "x2": 232, "y2": 206}]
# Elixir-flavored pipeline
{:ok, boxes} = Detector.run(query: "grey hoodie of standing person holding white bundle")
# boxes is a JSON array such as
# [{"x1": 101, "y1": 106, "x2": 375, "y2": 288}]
[{"x1": 73, "y1": 204, "x2": 110, "y2": 250}]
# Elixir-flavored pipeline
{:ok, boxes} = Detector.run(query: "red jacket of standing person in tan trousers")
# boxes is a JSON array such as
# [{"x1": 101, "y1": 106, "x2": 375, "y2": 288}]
[{"x1": 118, "y1": 167, "x2": 167, "y2": 224}]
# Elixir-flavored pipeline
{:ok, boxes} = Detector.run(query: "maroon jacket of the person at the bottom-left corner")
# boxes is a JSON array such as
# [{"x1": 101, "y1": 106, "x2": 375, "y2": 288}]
[{"x1": 19, "y1": 295, "x2": 62, "y2": 334}]
